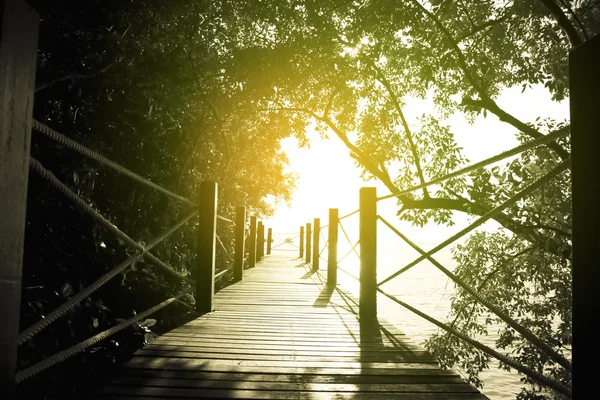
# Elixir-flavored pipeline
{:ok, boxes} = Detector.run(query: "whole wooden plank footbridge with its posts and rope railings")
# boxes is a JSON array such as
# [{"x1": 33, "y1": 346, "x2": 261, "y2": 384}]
[{"x1": 0, "y1": 0, "x2": 584, "y2": 399}]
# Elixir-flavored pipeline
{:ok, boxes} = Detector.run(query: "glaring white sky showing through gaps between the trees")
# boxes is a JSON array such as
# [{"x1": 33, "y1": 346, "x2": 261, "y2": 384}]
[{"x1": 264, "y1": 86, "x2": 569, "y2": 243}]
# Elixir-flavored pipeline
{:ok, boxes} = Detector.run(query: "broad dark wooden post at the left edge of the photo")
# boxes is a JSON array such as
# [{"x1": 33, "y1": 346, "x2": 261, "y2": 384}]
[{"x1": 0, "y1": 0, "x2": 39, "y2": 399}]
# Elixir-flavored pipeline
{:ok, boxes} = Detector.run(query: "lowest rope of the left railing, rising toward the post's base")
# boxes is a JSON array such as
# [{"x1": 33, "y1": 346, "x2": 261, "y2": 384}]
[{"x1": 16, "y1": 288, "x2": 192, "y2": 383}]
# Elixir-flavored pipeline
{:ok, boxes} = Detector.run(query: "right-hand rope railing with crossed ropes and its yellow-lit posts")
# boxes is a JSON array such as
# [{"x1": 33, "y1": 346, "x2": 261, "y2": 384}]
[{"x1": 294, "y1": 132, "x2": 572, "y2": 397}]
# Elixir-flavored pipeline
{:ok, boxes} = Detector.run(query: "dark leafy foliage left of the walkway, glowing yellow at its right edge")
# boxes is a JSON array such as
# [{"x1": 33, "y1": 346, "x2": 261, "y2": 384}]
[{"x1": 19, "y1": 0, "x2": 295, "y2": 399}]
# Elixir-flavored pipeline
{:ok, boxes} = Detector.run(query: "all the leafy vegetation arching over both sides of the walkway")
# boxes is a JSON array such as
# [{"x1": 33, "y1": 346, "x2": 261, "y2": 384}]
[{"x1": 20, "y1": 0, "x2": 600, "y2": 399}]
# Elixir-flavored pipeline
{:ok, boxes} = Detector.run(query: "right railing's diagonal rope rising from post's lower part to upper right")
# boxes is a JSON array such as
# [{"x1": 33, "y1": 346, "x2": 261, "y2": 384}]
[{"x1": 377, "y1": 158, "x2": 571, "y2": 286}]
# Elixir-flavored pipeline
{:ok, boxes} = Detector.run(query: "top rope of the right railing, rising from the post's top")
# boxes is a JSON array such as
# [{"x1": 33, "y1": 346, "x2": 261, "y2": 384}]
[{"x1": 378, "y1": 130, "x2": 569, "y2": 202}]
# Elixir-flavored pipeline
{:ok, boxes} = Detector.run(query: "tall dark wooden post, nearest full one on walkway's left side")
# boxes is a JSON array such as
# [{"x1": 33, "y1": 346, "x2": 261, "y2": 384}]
[{"x1": 195, "y1": 182, "x2": 218, "y2": 314}]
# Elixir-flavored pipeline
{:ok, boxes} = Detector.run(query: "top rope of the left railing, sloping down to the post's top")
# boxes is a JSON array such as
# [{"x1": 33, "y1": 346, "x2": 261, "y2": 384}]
[{"x1": 32, "y1": 119, "x2": 198, "y2": 207}]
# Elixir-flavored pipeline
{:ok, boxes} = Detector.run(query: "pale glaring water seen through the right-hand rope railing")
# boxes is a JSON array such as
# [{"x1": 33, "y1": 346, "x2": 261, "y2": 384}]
[{"x1": 312, "y1": 230, "x2": 523, "y2": 400}]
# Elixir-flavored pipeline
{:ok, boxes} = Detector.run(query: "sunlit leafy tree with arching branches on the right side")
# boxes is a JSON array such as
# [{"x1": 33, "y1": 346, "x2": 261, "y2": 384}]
[{"x1": 220, "y1": 0, "x2": 600, "y2": 398}]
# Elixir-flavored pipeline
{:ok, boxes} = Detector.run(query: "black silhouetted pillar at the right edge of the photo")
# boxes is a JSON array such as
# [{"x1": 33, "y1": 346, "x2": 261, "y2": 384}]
[{"x1": 569, "y1": 35, "x2": 600, "y2": 395}]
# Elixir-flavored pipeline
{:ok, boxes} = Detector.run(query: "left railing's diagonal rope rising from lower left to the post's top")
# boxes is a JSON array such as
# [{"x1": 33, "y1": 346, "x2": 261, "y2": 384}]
[{"x1": 18, "y1": 210, "x2": 198, "y2": 345}]
